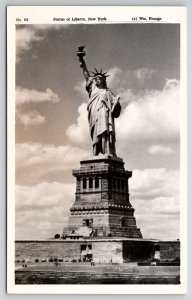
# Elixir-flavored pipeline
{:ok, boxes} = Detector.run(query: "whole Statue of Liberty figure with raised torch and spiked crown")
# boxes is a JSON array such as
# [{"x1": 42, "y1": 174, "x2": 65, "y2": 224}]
[{"x1": 77, "y1": 46, "x2": 121, "y2": 156}]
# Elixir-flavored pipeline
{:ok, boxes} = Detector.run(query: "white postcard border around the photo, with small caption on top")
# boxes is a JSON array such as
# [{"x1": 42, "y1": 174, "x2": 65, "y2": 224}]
[{"x1": 7, "y1": 6, "x2": 187, "y2": 294}]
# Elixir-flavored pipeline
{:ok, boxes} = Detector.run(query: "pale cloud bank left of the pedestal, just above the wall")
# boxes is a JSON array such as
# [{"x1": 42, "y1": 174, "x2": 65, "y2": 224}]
[{"x1": 16, "y1": 182, "x2": 75, "y2": 239}]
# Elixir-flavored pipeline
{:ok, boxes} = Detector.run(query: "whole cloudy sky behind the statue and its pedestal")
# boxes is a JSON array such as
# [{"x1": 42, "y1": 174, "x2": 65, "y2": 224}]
[{"x1": 15, "y1": 24, "x2": 180, "y2": 240}]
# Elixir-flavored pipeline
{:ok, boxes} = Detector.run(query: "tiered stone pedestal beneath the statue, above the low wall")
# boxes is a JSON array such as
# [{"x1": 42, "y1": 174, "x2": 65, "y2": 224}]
[{"x1": 63, "y1": 156, "x2": 142, "y2": 239}]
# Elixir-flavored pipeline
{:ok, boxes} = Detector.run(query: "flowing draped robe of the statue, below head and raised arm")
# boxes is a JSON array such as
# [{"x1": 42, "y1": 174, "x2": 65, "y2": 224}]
[{"x1": 86, "y1": 79, "x2": 118, "y2": 156}]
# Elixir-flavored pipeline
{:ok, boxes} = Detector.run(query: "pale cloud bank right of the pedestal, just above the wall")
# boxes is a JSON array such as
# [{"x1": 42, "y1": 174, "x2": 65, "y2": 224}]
[{"x1": 129, "y1": 168, "x2": 180, "y2": 239}]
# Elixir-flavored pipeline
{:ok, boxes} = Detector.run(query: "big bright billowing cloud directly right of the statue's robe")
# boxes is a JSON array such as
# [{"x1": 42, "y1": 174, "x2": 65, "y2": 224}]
[{"x1": 116, "y1": 80, "x2": 180, "y2": 143}]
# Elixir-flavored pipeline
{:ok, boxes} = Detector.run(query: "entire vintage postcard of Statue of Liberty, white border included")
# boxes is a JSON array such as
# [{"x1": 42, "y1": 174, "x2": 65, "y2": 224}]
[{"x1": 7, "y1": 6, "x2": 187, "y2": 294}]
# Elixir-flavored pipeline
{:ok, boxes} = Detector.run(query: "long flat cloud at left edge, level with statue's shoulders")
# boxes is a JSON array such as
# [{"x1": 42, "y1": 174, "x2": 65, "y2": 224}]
[{"x1": 16, "y1": 87, "x2": 60, "y2": 106}]
